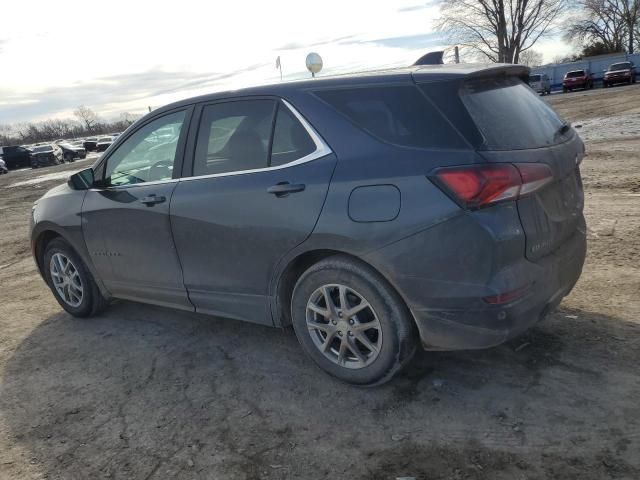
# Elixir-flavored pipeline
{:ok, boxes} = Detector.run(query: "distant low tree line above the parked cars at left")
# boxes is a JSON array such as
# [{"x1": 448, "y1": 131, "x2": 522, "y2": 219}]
[{"x1": 0, "y1": 105, "x2": 140, "y2": 145}]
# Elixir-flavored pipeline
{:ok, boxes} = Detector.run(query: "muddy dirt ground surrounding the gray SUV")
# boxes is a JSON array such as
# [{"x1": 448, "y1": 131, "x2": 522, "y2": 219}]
[{"x1": 0, "y1": 85, "x2": 640, "y2": 480}]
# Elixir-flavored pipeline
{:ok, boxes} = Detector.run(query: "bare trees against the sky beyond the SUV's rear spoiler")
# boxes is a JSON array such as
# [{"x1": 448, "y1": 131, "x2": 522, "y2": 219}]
[{"x1": 437, "y1": 0, "x2": 640, "y2": 66}]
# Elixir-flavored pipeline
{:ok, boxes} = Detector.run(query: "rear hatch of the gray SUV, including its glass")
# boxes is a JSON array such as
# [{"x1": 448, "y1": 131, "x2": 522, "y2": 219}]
[{"x1": 418, "y1": 66, "x2": 584, "y2": 261}]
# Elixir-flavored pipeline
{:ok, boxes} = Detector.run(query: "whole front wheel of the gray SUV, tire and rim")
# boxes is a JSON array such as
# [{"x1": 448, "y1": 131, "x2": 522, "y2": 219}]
[{"x1": 42, "y1": 238, "x2": 108, "y2": 317}]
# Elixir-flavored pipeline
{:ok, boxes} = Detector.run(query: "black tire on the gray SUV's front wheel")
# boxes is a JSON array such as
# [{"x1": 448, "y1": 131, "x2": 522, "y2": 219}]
[{"x1": 42, "y1": 238, "x2": 109, "y2": 317}]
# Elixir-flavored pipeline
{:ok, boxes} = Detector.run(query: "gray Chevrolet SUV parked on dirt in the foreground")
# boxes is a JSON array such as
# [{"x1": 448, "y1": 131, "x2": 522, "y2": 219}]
[{"x1": 31, "y1": 65, "x2": 586, "y2": 385}]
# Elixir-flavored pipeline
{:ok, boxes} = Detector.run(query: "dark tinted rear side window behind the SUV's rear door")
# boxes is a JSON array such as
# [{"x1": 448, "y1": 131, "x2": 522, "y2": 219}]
[{"x1": 316, "y1": 86, "x2": 468, "y2": 148}]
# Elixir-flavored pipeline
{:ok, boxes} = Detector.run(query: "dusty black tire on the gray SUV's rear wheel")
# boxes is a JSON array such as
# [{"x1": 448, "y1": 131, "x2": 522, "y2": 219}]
[{"x1": 291, "y1": 255, "x2": 417, "y2": 386}]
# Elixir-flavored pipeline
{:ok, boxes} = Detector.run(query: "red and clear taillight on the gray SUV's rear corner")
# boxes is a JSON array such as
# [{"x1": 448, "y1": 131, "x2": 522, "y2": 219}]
[{"x1": 432, "y1": 163, "x2": 553, "y2": 209}]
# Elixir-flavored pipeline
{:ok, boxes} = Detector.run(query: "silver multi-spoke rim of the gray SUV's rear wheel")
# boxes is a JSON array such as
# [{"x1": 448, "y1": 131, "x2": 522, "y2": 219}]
[{"x1": 306, "y1": 284, "x2": 382, "y2": 369}]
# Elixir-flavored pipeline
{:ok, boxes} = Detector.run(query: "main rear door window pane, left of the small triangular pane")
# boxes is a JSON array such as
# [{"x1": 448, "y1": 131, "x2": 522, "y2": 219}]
[{"x1": 193, "y1": 100, "x2": 276, "y2": 176}]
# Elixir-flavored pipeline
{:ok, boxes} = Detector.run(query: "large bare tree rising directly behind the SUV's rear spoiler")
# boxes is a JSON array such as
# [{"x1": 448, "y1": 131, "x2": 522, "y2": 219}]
[{"x1": 437, "y1": 0, "x2": 568, "y2": 63}]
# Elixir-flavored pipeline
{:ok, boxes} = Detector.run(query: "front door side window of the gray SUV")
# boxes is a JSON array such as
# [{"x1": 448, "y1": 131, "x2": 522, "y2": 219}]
[{"x1": 105, "y1": 111, "x2": 185, "y2": 186}]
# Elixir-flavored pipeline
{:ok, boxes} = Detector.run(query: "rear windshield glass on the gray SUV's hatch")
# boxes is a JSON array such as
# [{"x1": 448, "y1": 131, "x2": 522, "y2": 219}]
[{"x1": 461, "y1": 77, "x2": 564, "y2": 150}]
